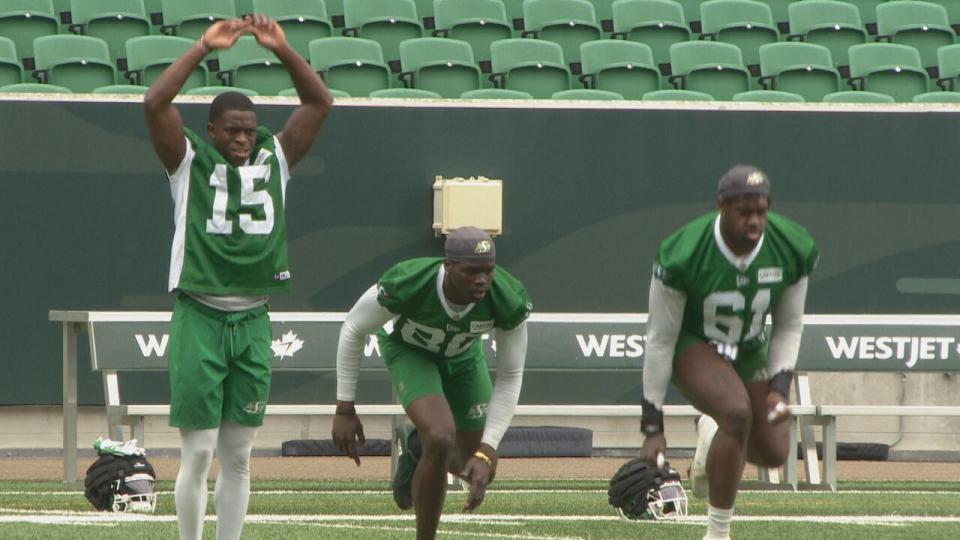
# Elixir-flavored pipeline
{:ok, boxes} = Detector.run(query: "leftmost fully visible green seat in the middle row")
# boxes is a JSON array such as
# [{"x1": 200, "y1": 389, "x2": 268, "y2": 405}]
[{"x1": 33, "y1": 34, "x2": 117, "y2": 92}]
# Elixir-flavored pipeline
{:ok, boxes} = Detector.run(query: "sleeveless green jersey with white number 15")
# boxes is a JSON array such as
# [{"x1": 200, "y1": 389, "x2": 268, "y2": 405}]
[{"x1": 169, "y1": 127, "x2": 290, "y2": 295}]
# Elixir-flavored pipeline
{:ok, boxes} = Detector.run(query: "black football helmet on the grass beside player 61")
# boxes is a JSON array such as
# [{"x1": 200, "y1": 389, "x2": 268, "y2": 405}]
[{"x1": 607, "y1": 459, "x2": 687, "y2": 521}]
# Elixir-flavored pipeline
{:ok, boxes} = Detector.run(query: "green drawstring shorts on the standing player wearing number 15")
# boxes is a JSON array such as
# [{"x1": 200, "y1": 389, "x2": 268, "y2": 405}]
[{"x1": 169, "y1": 293, "x2": 272, "y2": 429}]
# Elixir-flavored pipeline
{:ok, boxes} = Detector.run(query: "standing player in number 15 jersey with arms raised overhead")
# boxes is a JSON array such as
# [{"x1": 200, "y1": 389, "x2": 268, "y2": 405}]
[{"x1": 144, "y1": 15, "x2": 333, "y2": 540}]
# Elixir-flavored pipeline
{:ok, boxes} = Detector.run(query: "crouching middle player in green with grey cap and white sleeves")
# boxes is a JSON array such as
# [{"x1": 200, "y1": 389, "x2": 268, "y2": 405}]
[{"x1": 333, "y1": 227, "x2": 532, "y2": 540}]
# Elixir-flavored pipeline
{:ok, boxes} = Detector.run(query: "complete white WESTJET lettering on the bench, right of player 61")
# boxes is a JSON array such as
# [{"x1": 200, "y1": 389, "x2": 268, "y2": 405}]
[{"x1": 825, "y1": 336, "x2": 957, "y2": 367}]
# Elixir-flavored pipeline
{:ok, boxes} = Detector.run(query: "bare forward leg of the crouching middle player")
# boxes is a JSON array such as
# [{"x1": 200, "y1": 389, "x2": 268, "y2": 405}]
[{"x1": 407, "y1": 395, "x2": 457, "y2": 540}]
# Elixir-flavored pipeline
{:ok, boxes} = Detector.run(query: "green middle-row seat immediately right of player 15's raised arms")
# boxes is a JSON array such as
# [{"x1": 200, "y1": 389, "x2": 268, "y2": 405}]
[{"x1": 310, "y1": 37, "x2": 390, "y2": 97}]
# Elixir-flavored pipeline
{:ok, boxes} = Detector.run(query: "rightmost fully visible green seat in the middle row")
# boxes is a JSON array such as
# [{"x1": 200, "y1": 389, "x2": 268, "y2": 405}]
[{"x1": 848, "y1": 43, "x2": 929, "y2": 103}]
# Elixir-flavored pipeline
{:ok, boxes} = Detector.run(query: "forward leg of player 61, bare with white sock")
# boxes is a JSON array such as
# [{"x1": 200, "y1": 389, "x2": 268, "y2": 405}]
[{"x1": 674, "y1": 343, "x2": 753, "y2": 538}]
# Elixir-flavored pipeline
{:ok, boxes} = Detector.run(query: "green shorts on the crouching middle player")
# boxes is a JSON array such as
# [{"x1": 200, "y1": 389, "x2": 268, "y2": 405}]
[{"x1": 378, "y1": 336, "x2": 493, "y2": 431}]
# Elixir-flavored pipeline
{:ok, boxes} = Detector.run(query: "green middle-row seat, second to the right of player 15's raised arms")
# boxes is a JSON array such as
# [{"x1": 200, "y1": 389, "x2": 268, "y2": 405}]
[{"x1": 400, "y1": 38, "x2": 480, "y2": 98}]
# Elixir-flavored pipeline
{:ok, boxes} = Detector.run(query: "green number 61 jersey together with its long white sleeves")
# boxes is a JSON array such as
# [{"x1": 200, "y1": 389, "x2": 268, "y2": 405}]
[{"x1": 644, "y1": 212, "x2": 819, "y2": 407}]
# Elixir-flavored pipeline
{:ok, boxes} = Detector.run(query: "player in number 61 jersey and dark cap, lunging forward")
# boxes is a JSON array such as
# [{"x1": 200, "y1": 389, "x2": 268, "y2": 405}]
[{"x1": 641, "y1": 165, "x2": 819, "y2": 539}]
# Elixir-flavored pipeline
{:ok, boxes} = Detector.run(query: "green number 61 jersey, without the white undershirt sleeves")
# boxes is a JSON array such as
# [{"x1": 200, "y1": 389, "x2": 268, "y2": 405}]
[{"x1": 654, "y1": 212, "x2": 819, "y2": 360}]
